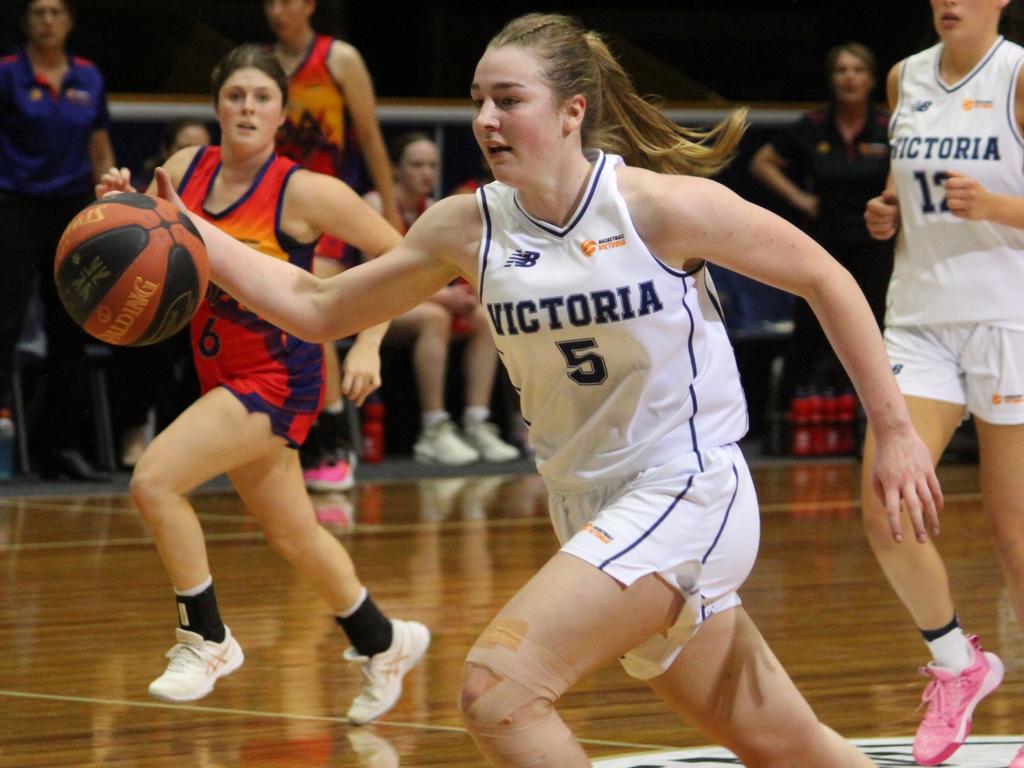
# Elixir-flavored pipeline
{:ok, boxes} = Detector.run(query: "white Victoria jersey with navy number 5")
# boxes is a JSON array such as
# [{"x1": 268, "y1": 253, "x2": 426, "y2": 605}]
[{"x1": 477, "y1": 153, "x2": 746, "y2": 493}]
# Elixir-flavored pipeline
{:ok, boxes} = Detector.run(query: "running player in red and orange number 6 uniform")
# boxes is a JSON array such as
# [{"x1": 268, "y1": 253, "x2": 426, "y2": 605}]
[{"x1": 97, "y1": 46, "x2": 430, "y2": 723}]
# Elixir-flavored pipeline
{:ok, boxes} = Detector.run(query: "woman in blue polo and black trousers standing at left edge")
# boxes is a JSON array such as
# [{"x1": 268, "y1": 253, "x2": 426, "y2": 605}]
[{"x1": 0, "y1": 0, "x2": 114, "y2": 479}]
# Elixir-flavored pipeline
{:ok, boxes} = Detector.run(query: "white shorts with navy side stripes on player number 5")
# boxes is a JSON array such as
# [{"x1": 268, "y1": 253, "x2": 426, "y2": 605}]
[{"x1": 550, "y1": 444, "x2": 761, "y2": 680}]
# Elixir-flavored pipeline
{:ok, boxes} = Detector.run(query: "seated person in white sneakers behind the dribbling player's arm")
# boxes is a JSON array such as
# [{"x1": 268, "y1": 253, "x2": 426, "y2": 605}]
[{"x1": 366, "y1": 133, "x2": 519, "y2": 466}]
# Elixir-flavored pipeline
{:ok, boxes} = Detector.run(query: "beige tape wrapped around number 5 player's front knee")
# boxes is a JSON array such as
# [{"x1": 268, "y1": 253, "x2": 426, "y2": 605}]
[{"x1": 466, "y1": 618, "x2": 575, "y2": 766}]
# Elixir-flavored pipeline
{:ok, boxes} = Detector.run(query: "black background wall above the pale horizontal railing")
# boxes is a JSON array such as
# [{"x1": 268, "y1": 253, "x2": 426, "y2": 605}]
[{"x1": 0, "y1": 0, "x2": 946, "y2": 101}]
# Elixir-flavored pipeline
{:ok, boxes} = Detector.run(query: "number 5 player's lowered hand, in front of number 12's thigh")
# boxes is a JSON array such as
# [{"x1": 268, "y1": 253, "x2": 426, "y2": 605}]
[{"x1": 871, "y1": 428, "x2": 942, "y2": 543}]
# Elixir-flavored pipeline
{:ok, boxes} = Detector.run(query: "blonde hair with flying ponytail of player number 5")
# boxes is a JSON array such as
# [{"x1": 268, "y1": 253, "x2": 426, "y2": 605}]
[{"x1": 490, "y1": 13, "x2": 746, "y2": 176}]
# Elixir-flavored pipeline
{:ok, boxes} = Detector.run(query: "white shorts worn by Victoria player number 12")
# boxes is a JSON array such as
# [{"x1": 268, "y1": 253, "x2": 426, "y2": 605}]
[{"x1": 885, "y1": 323, "x2": 1024, "y2": 424}]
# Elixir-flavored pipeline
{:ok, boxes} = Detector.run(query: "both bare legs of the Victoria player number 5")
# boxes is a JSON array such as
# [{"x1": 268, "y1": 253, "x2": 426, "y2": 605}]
[{"x1": 461, "y1": 553, "x2": 870, "y2": 768}]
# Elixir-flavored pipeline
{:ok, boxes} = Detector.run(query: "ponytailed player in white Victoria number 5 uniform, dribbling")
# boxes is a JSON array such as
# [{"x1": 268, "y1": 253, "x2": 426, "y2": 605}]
[{"x1": 144, "y1": 14, "x2": 941, "y2": 768}]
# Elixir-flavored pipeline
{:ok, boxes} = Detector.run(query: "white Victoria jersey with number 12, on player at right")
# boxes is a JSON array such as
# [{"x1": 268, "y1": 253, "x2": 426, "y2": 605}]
[{"x1": 886, "y1": 37, "x2": 1024, "y2": 326}]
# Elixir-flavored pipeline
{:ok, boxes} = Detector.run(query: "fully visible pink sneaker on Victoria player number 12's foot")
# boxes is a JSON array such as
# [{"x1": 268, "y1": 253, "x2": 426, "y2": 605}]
[{"x1": 913, "y1": 635, "x2": 999, "y2": 767}]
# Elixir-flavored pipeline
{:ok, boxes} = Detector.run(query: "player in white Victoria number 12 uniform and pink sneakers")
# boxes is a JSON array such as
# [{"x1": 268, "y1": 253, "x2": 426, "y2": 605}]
[{"x1": 863, "y1": 0, "x2": 1024, "y2": 768}]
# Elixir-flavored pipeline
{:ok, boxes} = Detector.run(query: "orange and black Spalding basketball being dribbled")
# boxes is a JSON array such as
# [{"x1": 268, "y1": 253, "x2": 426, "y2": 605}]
[{"x1": 53, "y1": 193, "x2": 210, "y2": 346}]
